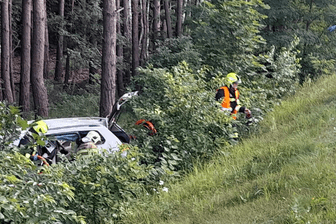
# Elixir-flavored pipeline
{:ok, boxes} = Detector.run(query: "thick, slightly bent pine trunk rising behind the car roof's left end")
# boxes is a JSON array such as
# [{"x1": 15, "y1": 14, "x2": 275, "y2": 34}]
[{"x1": 31, "y1": 1, "x2": 48, "y2": 117}]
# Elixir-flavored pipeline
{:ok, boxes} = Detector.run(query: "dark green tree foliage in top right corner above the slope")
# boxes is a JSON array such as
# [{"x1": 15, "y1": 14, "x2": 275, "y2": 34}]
[{"x1": 261, "y1": 0, "x2": 336, "y2": 81}]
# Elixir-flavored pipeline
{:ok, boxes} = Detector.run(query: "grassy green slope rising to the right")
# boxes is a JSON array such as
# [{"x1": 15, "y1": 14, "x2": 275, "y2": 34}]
[{"x1": 123, "y1": 76, "x2": 336, "y2": 223}]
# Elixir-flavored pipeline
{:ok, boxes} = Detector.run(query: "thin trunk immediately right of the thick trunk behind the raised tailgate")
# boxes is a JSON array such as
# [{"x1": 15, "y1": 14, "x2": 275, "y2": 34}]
[{"x1": 116, "y1": 0, "x2": 124, "y2": 96}]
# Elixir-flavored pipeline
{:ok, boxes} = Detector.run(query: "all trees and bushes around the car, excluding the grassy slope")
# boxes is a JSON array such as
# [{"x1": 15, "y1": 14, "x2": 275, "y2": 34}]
[{"x1": 0, "y1": 0, "x2": 336, "y2": 223}]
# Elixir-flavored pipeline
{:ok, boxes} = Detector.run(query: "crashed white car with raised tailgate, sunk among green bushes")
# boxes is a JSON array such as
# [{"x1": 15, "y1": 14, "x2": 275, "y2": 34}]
[{"x1": 14, "y1": 91, "x2": 138, "y2": 163}]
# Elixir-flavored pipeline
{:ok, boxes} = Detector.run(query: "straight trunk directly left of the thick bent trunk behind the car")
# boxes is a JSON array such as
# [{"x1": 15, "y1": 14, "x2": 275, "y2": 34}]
[{"x1": 19, "y1": 0, "x2": 32, "y2": 117}]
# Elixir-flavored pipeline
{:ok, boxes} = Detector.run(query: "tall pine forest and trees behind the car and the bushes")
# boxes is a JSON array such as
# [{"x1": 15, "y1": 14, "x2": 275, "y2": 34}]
[{"x1": 0, "y1": 0, "x2": 335, "y2": 117}]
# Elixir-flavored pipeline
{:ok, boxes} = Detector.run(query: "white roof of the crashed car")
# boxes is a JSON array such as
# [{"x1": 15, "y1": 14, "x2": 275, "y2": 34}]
[{"x1": 43, "y1": 117, "x2": 108, "y2": 131}]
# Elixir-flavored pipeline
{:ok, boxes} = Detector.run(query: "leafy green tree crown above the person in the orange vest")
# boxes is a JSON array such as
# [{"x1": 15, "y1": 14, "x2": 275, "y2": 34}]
[{"x1": 191, "y1": 0, "x2": 267, "y2": 73}]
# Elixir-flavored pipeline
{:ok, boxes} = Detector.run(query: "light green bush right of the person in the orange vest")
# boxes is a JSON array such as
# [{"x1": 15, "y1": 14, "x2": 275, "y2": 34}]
[{"x1": 247, "y1": 38, "x2": 300, "y2": 104}]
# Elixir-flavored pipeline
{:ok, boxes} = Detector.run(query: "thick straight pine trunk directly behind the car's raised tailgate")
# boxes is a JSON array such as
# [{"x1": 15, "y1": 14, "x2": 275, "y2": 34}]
[{"x1": 100, "y1": 0, "x2": 117, "y2": 117}]
